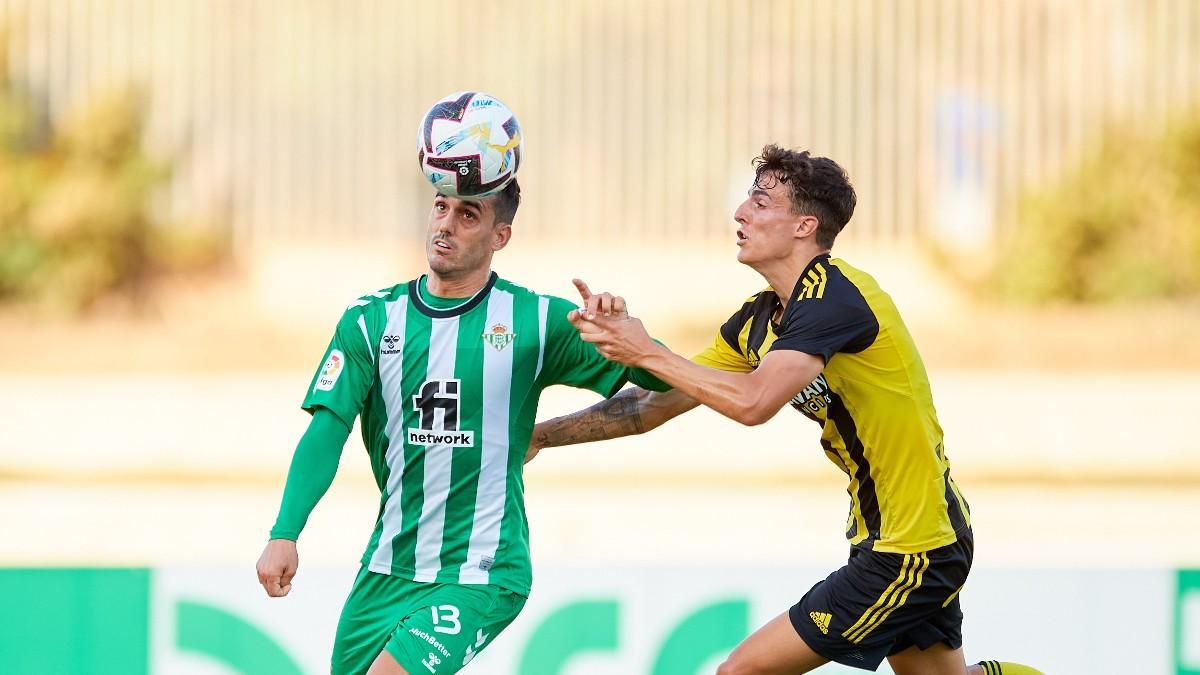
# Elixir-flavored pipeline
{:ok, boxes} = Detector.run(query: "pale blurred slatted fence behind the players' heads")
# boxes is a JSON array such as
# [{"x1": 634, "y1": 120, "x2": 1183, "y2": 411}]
[{"x1": 0, "y1": 0, "x2": 1200, "y2": 249}]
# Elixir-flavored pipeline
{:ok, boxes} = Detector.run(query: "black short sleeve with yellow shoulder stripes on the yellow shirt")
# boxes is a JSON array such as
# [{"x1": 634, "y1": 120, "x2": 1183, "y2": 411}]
[{"x1": 770, "y1": 280, "x2": 880, "y2": 363}]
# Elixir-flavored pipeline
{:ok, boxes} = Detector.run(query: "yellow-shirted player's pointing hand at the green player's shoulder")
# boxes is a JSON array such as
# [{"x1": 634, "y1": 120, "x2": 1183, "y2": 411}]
[{"x1": 566, "y1": 279, "x2": 661, "y2": 368}]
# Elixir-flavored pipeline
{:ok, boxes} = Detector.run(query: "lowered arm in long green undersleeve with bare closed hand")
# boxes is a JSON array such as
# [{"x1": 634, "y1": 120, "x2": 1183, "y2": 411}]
[{"x1": 257, "y1": 407, "x2": 350, "y2": 597}]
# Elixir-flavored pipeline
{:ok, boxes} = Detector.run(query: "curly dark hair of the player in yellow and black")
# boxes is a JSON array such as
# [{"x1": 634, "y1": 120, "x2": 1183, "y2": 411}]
[{"x1": 752, "y1": 144, "x2": 858, "y2": 249}]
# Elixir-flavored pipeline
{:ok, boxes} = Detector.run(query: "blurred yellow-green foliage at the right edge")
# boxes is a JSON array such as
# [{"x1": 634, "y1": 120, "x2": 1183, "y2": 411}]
[{"x1": 992, "y1": 115, "x2": 1200, "y2": 303}]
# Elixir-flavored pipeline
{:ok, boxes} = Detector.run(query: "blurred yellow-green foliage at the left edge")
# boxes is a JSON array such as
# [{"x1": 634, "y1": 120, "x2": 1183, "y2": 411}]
[{"x1": 0, "y1": 29, "x2": 228, "y2": 313}]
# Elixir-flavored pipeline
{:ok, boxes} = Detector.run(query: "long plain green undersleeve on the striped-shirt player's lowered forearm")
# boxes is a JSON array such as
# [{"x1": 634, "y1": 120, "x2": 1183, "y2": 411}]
[{"x1": 271, "y1": 407, "x2": 350, "y2": 542}]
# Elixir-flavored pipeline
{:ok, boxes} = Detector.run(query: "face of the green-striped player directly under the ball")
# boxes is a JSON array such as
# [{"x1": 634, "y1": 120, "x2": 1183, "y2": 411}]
[{"x1": 425, "y1": 195, "x2": 508, "y2": 276}]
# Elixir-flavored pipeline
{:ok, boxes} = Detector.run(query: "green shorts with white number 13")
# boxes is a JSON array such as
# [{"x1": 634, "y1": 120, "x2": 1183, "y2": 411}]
[{"x1": 330, "y1": 567, "x2": 526, "y2": 675}]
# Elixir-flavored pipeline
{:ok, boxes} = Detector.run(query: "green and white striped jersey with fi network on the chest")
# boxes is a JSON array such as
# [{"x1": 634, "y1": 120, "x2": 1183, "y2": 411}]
[{"x1": 297, "y1": 273, "x2": 665, "y2": 595}]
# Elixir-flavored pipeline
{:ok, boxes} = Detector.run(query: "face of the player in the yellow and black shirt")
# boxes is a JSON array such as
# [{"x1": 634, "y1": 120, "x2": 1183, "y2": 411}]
[{"x1": 733, "y1": 174, "x2": 811, "y2": 265}]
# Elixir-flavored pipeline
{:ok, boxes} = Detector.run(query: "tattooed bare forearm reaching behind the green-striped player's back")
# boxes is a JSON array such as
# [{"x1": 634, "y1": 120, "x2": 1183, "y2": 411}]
[{"x1": 526, "y1": 387, "x2": 700, "y2": 462}]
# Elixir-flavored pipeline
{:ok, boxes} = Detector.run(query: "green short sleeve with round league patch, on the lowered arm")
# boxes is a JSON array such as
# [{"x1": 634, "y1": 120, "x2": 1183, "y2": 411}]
[{"x1": 301, "y1": 300, "x2": 374, "y2": 426}]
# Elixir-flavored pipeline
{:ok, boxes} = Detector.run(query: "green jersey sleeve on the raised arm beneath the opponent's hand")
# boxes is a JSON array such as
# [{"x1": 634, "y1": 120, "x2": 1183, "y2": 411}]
[{"x1": 540, "y1": 298, "x2": 671, "y2": 398}]
